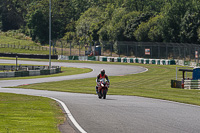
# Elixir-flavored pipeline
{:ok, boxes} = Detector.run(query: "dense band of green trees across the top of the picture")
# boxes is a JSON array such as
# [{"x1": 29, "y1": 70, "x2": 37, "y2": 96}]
[{"x1": 0, "y1": 0, "x2": 200, "y2": 44}]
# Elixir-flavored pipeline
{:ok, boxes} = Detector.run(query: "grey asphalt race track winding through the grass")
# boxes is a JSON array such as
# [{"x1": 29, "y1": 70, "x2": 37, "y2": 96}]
[{"x1": 0, "y1": 60, "x2": 200, "y2": 133}]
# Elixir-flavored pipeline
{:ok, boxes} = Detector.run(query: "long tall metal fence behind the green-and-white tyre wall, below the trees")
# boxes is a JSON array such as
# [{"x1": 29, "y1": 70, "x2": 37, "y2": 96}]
[{"x1": 55, "y1": 41, "x2": 200, "y2": 60}]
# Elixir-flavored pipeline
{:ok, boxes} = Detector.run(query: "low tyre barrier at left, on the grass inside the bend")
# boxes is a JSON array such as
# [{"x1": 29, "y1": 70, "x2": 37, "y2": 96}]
[{"x1": 0, "y1": 66, "x2": 61, "y2": 78}]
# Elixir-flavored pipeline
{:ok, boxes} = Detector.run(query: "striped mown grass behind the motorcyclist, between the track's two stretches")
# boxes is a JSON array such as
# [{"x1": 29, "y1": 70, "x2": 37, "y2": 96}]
[{"x1": 9, "y1": 61, "x2": 200, "y2": 105}]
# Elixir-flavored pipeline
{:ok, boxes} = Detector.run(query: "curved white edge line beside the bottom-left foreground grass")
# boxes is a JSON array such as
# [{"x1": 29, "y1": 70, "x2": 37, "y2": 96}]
[{"x1": 49, "y1": 97, "x2": 87, "y2": 133}]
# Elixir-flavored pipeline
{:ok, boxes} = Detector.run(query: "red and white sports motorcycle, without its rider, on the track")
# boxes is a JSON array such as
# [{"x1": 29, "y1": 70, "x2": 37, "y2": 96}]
[{"x1": 98, "y1": 79, "x2": 110, "y2": 99}]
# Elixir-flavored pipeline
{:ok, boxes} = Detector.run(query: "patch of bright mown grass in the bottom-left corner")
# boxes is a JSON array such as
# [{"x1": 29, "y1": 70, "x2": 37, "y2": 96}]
[{"x1": 0, "y1": 93, "x2": 65, "y2": 133}]
